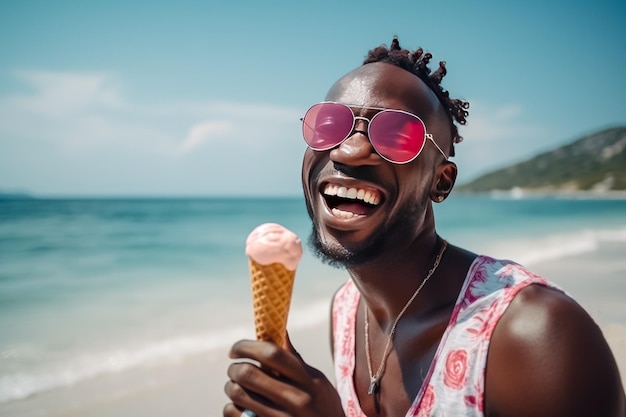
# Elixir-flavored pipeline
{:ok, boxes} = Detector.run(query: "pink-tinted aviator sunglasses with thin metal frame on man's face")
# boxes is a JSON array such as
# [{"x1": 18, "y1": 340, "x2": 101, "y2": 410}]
[{"x1": 302, "y1": 101, "x2": 448, "y2": 164}]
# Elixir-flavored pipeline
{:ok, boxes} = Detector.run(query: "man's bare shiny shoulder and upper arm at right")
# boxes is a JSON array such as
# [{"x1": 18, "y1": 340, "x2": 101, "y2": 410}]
[{"x1": 485, "y1": 285, "x2": 626, "y2": 417}]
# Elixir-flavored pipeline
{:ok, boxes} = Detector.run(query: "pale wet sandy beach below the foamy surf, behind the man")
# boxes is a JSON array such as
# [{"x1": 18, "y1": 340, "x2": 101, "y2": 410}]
[{"x1": 0, "y1": 243, "x2": 626, "y2": 417}]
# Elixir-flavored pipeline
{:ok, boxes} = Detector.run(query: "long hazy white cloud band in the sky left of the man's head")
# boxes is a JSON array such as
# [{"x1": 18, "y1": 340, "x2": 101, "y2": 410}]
[{"x1": 0, "y1": 71, "x2": 297, "y2": 155}]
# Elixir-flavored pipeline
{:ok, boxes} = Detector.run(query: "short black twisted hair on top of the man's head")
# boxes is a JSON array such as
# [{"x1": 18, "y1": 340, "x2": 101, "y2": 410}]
[{"x1": 363, "y1": 36, "x2": 469, "y2": 156}]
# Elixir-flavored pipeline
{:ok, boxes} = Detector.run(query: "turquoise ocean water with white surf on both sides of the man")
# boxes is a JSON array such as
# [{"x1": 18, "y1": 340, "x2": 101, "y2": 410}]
[{"x1": 0, "y1": 195, "x2": 626, "y2": 404}]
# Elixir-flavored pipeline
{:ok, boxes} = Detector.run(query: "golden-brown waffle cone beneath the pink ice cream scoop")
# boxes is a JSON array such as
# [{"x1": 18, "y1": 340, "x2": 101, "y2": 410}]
[{"x1": 249, "y1": 258, "x2": 296, "y2": 347}]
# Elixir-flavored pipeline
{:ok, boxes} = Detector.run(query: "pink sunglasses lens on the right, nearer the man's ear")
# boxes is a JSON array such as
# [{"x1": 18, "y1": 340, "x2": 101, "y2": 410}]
[{"x1": 369, "y1": 110, "x2": 426, "y2": 164}]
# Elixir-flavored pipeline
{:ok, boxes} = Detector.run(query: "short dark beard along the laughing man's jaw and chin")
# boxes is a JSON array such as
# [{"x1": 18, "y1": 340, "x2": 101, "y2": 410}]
[{"x1": 308, "y1": 197, "x2": 425, "y2": 269}]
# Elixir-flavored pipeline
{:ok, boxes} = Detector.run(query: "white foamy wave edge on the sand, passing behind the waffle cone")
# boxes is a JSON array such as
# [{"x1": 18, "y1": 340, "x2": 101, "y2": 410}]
[{"x1": 0, "y1": 300, "x2": 329, "y2": 403}]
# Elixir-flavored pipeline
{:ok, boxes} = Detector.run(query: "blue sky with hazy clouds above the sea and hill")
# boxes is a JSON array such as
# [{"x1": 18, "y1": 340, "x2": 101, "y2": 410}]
[{"x1": 0, "y1": 0, "x2": 626, "y2": 196}]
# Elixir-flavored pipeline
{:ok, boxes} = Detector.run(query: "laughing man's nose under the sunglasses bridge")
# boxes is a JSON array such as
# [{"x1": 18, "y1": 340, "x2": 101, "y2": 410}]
[{"x1": 330, "y1": 117, "x2": 383, "y2": 166}]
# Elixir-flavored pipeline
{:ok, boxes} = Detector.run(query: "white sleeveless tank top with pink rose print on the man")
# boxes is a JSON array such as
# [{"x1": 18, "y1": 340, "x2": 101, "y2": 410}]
[{"x1": 332, "y1": 256, "x2": 557, "y2": 417}]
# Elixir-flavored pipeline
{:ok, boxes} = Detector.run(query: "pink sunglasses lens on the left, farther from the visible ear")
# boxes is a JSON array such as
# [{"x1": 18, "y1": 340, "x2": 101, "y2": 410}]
[{"x1": 302, "y1": 103, "x2": 354, "y2": 151}]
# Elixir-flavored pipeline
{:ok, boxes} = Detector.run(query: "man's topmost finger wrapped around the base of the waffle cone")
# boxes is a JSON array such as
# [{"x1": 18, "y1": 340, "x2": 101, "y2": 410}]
[{"x1": 230, "y1": 340, "x2": 308, "y2": 381}]
